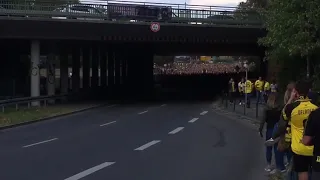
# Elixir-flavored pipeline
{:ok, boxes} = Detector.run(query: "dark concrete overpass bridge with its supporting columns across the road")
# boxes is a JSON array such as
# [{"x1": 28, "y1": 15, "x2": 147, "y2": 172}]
[{"x1": 0, "y1": 1, "x2": 266, "y2": 101}]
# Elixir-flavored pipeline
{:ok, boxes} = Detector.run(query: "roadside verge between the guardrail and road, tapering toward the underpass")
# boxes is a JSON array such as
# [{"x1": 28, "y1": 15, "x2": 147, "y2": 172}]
[{"x1": 0, "y1": 102, "x2": 103, "y2": 128}]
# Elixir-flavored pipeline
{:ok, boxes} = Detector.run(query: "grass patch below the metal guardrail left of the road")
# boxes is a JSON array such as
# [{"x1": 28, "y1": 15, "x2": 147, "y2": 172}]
[{"x1": 0, "y1": 106, "x2": 84, "y2": 127}]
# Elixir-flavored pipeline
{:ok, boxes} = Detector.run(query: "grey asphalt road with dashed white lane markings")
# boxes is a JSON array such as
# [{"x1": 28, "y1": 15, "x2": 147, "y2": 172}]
[{"x1": 0, "y1": 102, "x2": 266, "y2": 180}]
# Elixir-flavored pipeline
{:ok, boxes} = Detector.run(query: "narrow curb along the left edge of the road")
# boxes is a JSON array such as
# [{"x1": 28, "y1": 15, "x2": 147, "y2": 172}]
[{"x1": 0, "y1": 104, "x2": 111, "y2": 131}]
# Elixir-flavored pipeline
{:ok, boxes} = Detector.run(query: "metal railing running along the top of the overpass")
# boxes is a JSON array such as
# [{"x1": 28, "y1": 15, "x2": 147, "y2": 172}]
[{"x1": 0, "y1": 0, "x2": 261, "y2": 24}]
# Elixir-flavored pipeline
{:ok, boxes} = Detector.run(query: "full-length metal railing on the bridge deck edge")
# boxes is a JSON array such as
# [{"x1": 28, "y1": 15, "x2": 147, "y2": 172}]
[{"x1": 0, "y1": 0, "x2": 262, "y2": 25}]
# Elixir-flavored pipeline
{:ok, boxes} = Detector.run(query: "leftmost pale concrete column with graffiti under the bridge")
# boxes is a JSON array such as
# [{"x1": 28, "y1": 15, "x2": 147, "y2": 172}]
[{"x1": 30, "y1": 40, "x2": 40, "y2": 106}]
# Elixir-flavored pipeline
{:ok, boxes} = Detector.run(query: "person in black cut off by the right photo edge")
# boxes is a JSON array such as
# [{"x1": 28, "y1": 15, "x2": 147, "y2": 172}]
[{"x1": 302, "y1": 108, "x2": 320, "y2": 180}]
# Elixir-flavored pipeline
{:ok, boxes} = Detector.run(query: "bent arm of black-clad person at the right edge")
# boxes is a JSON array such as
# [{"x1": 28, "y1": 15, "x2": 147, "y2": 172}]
[{"x1": 302, "y1": 110, "x2": 318, "y2": 146}]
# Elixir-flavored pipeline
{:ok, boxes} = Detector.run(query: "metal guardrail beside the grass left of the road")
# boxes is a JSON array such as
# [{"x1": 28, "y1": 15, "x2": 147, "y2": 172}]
[{"x1": 0, "y1": 94, "x2": 68, "y2": 112}]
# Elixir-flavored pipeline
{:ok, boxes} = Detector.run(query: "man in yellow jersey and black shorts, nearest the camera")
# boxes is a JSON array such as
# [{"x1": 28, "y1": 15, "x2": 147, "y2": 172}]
[{"x1": 268, "y1": 81, "x2": 318, "y2": 180}]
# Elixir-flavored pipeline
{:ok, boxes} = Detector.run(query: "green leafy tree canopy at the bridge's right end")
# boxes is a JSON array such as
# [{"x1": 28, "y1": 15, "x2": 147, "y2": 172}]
[{"x1": 259, "y1": 0, "x2": 320, "y2": 56}]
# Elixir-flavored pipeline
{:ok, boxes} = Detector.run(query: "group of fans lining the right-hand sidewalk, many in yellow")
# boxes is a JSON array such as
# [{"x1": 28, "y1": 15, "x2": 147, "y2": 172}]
[{"x1": 229, "y1": 77, "x2": 320, "y2": 180}]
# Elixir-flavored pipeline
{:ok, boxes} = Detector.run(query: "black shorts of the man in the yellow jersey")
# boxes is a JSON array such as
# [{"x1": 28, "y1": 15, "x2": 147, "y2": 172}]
[{"x1": 292, "y1": 153, "x2": 312, "y2": 173}]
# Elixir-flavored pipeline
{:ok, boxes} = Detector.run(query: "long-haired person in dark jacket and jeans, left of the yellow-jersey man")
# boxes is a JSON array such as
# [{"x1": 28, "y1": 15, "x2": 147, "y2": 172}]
[{"x1": 259, "y1": 93, "x2": 286, "y2": 173}]
